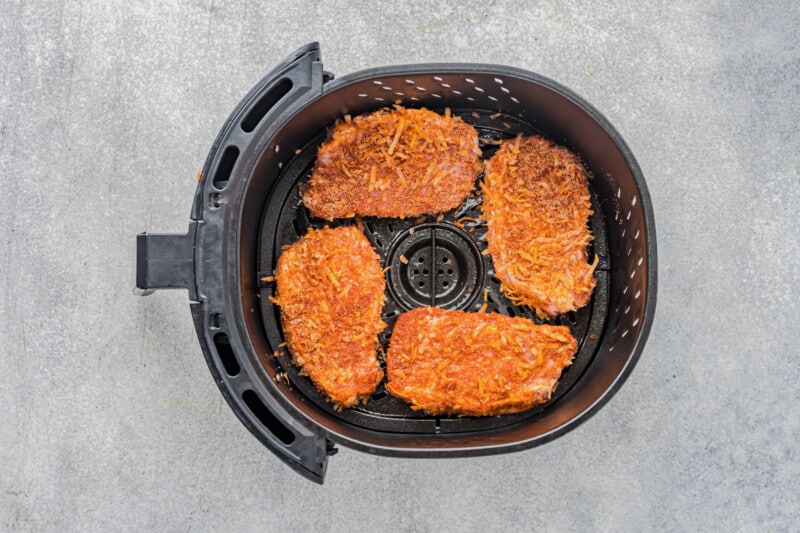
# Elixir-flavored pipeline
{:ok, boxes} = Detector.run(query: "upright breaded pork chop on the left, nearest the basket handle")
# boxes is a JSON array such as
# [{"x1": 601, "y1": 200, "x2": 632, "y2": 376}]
[{"x1": 272, "y1": 227, "x2": 386, "y2": 407}]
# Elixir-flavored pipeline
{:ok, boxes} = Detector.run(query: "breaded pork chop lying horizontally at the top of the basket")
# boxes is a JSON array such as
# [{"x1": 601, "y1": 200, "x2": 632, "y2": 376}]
[{"x1": 303, "y1": 106, "x2": 482, "y2": 220}]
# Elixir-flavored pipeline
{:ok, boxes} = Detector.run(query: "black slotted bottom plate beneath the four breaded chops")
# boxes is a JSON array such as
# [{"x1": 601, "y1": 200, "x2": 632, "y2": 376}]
[{"x1": 259, "y1": 109, "x2": 608, "y2": 433}]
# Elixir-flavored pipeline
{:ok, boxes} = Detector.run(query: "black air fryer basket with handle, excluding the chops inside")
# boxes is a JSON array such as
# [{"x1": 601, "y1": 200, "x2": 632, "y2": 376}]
[{"x1": 137, "y1": 43, "x2": 656, "y2": 482}]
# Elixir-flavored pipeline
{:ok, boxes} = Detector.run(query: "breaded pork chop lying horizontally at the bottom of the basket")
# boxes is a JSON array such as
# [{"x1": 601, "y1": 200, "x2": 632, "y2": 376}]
[{"x1": 386, "y1": 307, "x2": 578, "y2": 416}]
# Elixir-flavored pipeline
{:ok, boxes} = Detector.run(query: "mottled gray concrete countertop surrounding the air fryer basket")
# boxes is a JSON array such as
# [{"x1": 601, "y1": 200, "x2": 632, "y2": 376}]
[{"x1": 0, "y1": 0, "x2": 800, "y2": 531}]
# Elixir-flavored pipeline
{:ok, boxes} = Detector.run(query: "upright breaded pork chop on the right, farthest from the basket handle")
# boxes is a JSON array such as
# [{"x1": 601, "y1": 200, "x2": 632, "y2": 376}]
[{"x1": 483, "y1": 136, "x2": 597, "y2": 318}]
